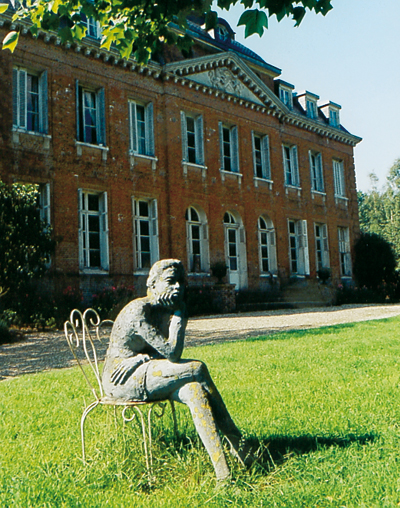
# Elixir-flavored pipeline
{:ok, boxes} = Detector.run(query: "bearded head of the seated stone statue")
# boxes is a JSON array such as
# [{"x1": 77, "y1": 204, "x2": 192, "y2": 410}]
[{"x1": 147, "y1": 259, "x2": 185, "y2": 309}]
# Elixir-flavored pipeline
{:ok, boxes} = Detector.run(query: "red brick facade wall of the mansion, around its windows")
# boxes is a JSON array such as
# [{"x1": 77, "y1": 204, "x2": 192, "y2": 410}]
[{"x1": 0, "y1": 29, "x2": 359, "y2": 298}]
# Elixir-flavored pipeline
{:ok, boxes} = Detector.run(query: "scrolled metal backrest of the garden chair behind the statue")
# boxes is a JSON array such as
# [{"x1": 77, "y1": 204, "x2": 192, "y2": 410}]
[{"x1": 64, "y1": 309, "x2": 113, "y2": 400}]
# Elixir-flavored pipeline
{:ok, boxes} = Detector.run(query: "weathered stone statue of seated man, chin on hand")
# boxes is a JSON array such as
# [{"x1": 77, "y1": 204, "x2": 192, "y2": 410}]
[{"x1": 103, "y1": 259, "x2": 249, "y2": 480}]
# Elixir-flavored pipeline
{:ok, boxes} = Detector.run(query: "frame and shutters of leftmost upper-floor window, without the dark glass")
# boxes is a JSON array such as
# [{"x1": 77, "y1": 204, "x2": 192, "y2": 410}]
[{"x1": 13, "y1": 67, "x2": 49, "y2": 134}]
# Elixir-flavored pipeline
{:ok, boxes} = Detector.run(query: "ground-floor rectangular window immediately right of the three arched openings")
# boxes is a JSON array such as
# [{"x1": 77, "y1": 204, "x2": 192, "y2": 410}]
[{"x1": 288, "y1": 220, "x2": 310, "y2": 275}]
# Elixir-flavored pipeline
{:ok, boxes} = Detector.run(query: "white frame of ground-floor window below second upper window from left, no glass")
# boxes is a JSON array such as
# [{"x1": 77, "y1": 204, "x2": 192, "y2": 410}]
[{"x1": 78, "y1": 189, "x2": 109, "y2": 273}]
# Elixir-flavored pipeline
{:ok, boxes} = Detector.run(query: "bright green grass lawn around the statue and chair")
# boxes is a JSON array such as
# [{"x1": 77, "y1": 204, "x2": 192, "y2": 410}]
[{"x1": 0, "y1": 318, "x2": 400, "y2": 508}]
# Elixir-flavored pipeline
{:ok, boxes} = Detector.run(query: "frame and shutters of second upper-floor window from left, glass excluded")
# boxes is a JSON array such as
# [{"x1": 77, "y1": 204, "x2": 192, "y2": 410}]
[{"x1": 76, "y1": 80, "x2": 106, "y2": 147}]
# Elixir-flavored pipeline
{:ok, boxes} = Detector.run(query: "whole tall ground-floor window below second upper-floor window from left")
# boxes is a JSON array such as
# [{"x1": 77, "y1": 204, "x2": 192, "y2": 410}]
[{"x1": 78, "y1": 189, "x2": 109, "y2": 270}]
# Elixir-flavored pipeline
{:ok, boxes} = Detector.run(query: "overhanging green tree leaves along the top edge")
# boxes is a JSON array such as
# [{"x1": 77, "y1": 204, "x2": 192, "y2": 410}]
[{"x1": 0, "y1": 0, "x2": 332, "y2": 63}]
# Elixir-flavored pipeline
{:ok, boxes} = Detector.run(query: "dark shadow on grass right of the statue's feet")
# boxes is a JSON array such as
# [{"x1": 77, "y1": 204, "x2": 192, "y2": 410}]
[{"x1": 249, "y1": 433, "x2": 379, "y2": 471}]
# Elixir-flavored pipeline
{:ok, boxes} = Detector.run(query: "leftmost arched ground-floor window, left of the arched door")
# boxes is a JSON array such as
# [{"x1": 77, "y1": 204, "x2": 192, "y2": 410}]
[{"x1": 185, "y1": 206, "x2": 209, "y2": 273}]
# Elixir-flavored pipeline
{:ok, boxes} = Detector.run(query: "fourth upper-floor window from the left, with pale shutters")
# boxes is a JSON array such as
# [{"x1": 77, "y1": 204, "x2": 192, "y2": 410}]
[{"x1": 181, "y1": 111, "x2": 204, "y2": 165}]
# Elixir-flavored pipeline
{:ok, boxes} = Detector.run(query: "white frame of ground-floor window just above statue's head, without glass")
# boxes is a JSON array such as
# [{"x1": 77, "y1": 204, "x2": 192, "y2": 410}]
[{"x1": 132, "y1": 196, "x2": 160, "y2": 273}]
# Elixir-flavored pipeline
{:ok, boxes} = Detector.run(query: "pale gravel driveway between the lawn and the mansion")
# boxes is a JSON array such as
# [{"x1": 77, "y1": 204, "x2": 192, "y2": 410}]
[{"x1": 0, "y1": 305, "x2": 400, "y2": 380}]
